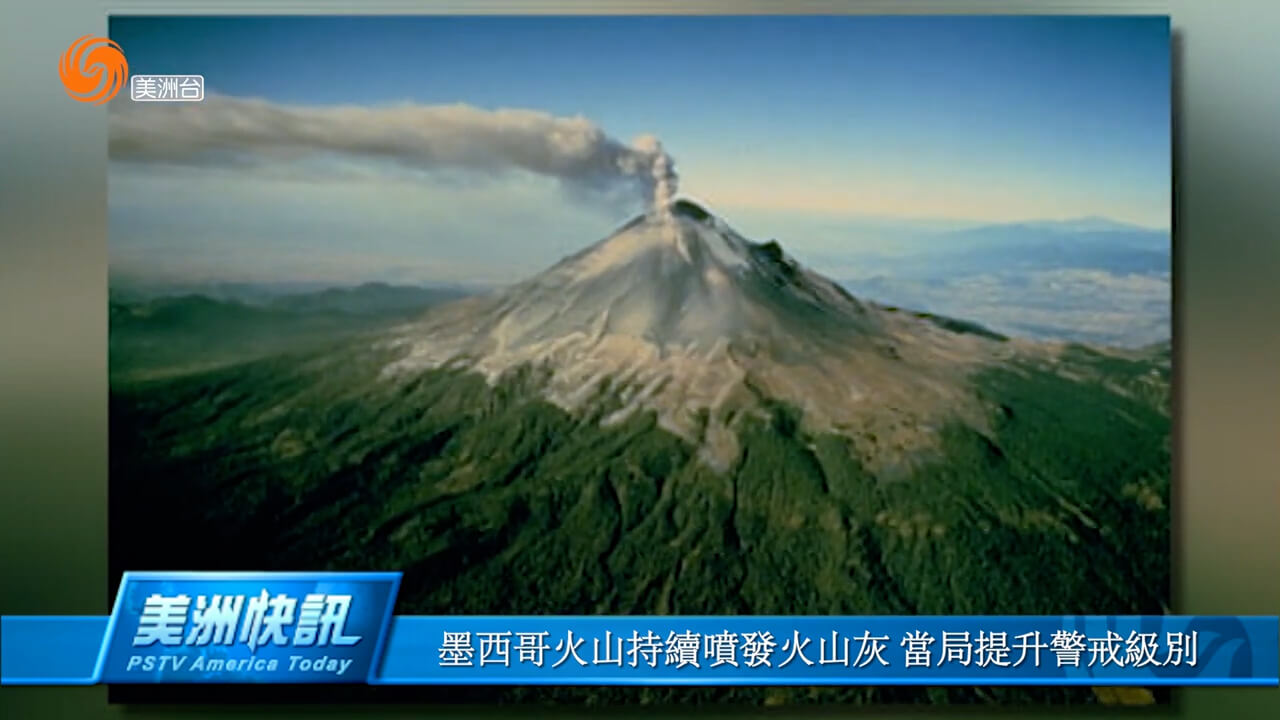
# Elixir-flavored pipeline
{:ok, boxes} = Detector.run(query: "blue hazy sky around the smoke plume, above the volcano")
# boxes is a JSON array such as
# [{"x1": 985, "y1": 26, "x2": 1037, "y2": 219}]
[{"x1": 110, "y1": 15, "x2": 1170, "y2": 282}]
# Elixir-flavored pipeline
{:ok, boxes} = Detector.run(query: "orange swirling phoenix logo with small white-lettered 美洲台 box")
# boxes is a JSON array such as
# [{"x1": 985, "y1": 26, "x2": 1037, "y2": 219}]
[{"x1": 58, "y1": 35, "x2": 205, "y2": 105}]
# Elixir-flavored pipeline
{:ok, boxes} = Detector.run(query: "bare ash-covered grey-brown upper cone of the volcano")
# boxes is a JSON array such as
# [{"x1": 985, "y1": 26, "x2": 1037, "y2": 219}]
[{"x1": 387, "y1": 200, "x2": 1021, "y2": 466}]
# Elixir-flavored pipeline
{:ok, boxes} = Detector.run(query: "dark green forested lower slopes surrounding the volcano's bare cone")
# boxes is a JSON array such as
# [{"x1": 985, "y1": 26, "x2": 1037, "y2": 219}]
[{"x1": 110, "y1": 319, "x2": 1170, "y2": 703}]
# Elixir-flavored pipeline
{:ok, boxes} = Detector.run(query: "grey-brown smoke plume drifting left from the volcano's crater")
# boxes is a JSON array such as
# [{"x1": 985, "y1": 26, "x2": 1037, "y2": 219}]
[{"x1": 109, "y1": 95, "x2": 676, "y2": 208}]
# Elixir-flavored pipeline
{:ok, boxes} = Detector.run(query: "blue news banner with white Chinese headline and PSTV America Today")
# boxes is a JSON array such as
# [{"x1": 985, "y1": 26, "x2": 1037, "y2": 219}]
[{"x1": 0, "y1": 573, "x2": 1280, "y2": 687}]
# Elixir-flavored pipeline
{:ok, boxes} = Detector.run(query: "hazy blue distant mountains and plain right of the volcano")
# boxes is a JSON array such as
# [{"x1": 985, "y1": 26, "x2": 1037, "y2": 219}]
[{"x1": 819, "y1": 218, "x2": 1172, "y2": 347}]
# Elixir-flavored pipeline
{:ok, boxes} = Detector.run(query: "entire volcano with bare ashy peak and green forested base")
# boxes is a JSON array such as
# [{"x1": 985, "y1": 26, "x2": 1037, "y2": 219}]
[{"x1": 110, "y1": 200, "x2": 1170, "y2": 701}]
